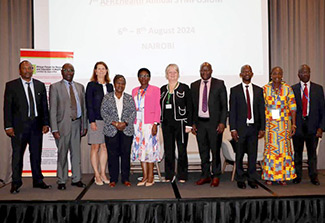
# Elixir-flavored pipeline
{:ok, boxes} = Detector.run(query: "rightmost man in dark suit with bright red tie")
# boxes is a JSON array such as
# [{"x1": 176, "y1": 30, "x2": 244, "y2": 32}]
[{"x1": 292, "y1": 64, "x2": 325, "y2": 185}]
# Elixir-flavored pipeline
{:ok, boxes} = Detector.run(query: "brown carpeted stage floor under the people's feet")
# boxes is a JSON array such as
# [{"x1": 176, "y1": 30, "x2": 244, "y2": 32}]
[{"x1": 0, "y1": 170, "x2": 325, "y2": 201}]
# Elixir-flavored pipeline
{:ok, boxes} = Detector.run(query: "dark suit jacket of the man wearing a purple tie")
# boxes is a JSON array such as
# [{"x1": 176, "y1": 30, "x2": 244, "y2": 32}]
[{"x1": 191, "y1": 77, "x2": 228, "y2": 128}]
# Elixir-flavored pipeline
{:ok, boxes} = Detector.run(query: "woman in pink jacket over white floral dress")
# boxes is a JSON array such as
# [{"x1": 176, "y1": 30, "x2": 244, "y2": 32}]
[{"x1": 132, "y1": 68, "x2": 161, "y2": 187}]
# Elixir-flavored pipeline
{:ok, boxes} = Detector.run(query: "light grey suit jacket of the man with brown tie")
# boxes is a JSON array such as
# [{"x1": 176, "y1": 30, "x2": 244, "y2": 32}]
[{"x1": 50, "y1": 79, "x2": 87, "y2": 136}]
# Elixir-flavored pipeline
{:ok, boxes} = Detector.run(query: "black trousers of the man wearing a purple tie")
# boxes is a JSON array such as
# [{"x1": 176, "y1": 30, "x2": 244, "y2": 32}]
[{"x1": 196, "y1": 119, "x2": 223, "y2": 178}]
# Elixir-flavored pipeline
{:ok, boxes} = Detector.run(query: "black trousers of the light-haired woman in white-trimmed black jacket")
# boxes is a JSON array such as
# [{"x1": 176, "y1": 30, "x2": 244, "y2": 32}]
[{"x1": 162, "y1": 121, "x2": 188, "y2": 180}]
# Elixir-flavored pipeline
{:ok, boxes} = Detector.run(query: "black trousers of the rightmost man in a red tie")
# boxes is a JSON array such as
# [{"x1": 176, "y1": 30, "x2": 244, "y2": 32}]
[{"x1": 292, "y1": 119, "x2": 318, "y2": 179}]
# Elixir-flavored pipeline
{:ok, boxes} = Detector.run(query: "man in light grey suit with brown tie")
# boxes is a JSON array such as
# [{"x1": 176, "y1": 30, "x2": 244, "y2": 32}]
[{"x1": 50, "y1": 63, "x2": 87, "y2": 190}]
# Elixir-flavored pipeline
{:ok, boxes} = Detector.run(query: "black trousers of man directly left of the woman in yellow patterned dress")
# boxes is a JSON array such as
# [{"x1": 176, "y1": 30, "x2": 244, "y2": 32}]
[{"x1": 236, "y1": 125, "x2": 258, "y2": 182}]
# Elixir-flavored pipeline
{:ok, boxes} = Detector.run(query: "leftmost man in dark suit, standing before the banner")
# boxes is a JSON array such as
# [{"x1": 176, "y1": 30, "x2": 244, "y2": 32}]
[{"x1": 3, "y1": 60, "x2": 51, "y2": 193}]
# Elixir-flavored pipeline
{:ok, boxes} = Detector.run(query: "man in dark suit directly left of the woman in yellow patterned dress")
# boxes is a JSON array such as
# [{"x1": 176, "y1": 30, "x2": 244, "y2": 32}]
[{"x1": 229, "y1": 65, "x2": 265, "y2": 189}]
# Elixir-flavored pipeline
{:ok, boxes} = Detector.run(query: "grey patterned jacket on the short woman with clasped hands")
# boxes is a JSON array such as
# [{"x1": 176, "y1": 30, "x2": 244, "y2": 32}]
[{"x1": 101, "y1": 92, "x2": 136, "y2": 137}]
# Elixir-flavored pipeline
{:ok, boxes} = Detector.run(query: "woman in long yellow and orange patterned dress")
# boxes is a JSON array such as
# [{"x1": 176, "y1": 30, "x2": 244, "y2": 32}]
[{"x1": 262, "y1": 67, "x2": 297, "y2": 185}]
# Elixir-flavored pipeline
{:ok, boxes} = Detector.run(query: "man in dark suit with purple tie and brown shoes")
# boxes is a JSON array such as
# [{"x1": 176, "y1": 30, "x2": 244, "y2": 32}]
[{"x1": 191, "y1": 62, "x2": 228, "y2": 187}]
